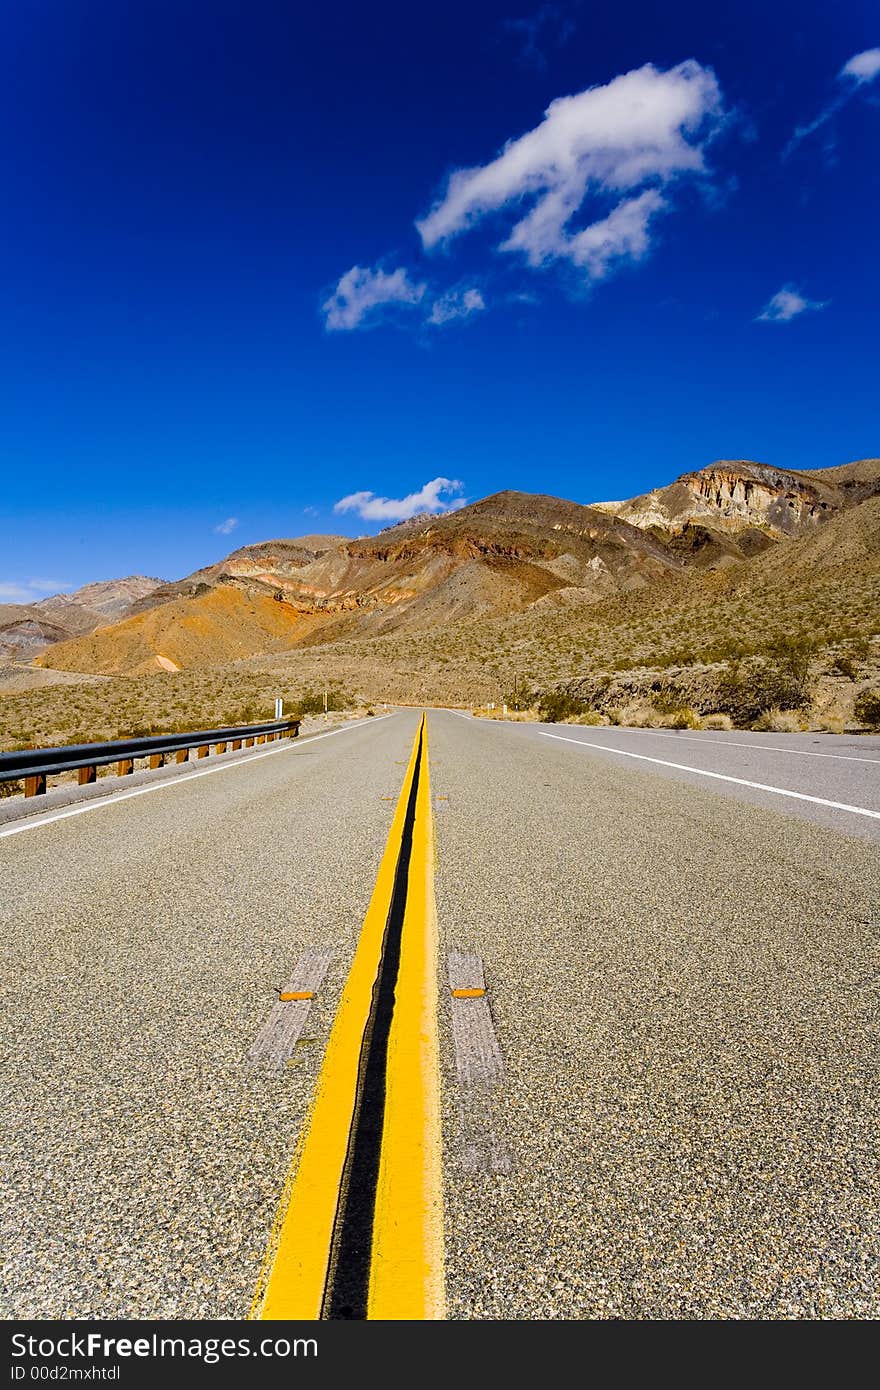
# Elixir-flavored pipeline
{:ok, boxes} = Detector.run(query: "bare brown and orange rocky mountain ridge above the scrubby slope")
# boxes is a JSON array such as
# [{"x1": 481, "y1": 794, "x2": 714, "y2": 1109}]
[{"x1": 32, "y1": 460, "x2": 880, "y2": 674}]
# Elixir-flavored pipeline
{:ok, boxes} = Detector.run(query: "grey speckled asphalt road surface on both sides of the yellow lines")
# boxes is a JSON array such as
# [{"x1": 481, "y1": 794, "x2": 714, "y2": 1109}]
[{"x1": 0, "y1": 712, "x2": 880, "y2": 1319}]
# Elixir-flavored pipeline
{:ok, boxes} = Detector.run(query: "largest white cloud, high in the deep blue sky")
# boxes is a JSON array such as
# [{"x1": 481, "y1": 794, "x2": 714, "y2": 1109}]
[{"x1": 416, "y1": 60, "x2": 724, "y2": 279}]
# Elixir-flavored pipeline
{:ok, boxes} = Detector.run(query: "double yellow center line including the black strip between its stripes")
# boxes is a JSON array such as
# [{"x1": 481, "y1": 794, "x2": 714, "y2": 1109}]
[{"x1": 252, "y1": 714, "x2": 445, "y2": 1321}]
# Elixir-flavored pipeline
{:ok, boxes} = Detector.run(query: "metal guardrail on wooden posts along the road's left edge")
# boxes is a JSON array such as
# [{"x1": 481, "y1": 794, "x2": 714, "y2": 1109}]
[{"x1": 0, "y1": 719, "x2": 300, "y2": 796}]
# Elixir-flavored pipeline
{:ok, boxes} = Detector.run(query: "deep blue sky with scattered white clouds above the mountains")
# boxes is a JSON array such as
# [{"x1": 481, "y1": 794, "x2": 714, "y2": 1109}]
[{"x1": 0, "y1": 0, "x2": 880, "y2": 600}]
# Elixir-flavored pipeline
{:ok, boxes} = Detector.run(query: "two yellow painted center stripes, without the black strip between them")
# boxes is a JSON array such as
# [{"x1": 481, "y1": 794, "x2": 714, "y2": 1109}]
[{"x1": 252, "y1": 714, "x2": 443, "y2": 1319}]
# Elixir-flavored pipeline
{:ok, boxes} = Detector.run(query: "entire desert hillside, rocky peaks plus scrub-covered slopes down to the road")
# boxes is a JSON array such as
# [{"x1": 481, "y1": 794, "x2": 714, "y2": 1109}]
[{"x1": 0, "y1": 459, "x2": 880, "y2": 744}]
